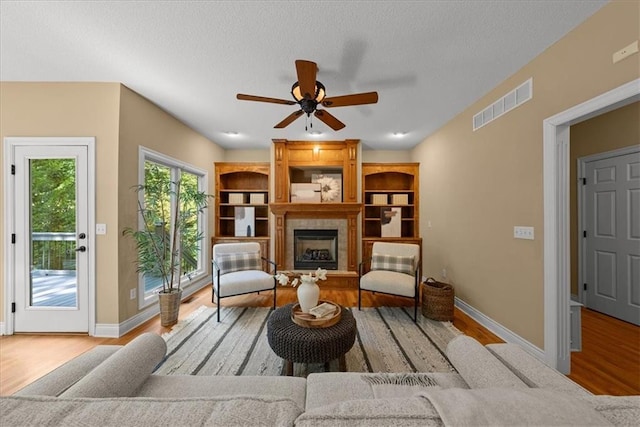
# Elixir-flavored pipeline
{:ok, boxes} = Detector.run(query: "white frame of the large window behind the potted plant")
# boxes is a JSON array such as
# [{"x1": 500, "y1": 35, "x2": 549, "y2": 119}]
[{"x1": 137, "y1": 146, "x2": 209, "y2": 309}]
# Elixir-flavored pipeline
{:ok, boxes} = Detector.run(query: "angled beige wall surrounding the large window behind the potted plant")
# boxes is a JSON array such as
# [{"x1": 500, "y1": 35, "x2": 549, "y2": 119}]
[{"x1": 119, "y1": 86, "x2": 224, "y2": 322}]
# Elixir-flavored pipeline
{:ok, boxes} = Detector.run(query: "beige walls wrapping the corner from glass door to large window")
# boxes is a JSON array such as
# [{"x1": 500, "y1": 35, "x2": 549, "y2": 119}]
[{"x1": 0, "y1": 83, "x2": 224, "y2": 324}]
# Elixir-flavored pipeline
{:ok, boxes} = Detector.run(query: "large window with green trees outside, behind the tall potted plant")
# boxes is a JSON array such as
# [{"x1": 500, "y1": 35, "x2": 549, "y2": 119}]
[{"x1": 138, "y1": 148, "x2": 207, "y2": 308}]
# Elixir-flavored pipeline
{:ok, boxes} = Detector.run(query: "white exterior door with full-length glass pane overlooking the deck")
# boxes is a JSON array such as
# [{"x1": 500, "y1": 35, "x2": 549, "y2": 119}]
[{"x1": 13, "y1": 144, "x2": 92, "y2": 332}]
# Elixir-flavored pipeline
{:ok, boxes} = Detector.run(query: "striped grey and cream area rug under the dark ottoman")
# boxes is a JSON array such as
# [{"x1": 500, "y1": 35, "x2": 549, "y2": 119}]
[{"x1": 155, "y1": 306, "x2": 461, "y2": 377}]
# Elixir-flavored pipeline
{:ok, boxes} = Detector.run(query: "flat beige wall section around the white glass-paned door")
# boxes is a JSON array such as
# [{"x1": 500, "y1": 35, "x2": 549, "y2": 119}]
[{"x1": 0, "y1": 82, "x2": 120, "y2": 323}]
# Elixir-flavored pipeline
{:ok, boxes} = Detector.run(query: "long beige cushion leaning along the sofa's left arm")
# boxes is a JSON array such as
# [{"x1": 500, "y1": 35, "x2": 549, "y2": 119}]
[{"x1": 60, "y1": 333, "x2": 167, "y2": 397}]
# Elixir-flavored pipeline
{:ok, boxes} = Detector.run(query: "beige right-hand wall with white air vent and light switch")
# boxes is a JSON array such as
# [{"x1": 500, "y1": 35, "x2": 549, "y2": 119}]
[{"x1": 412, "y1": 1, "x2": 640, "y2": 348}]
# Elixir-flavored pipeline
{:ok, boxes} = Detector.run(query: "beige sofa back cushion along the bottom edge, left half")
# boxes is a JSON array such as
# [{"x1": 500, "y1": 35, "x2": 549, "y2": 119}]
[{"x1": 0, "y1": 396, "x2": 302, "y2": 427}]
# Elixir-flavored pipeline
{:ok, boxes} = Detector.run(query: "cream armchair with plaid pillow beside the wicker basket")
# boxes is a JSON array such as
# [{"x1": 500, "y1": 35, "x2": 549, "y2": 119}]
[{"x1": 358, "y1": 242, "x2": 420, "y2": 322}]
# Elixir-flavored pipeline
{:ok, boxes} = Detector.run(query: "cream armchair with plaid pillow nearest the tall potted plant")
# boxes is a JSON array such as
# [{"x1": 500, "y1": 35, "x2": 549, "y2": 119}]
[{"x1": 211, "y1": 242, "x2": 277, "y2": 322}]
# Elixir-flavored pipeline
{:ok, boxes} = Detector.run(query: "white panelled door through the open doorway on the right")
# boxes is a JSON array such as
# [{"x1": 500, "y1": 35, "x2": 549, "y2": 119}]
[{"x1": 584, "y1": 151, "x2": 640, "y2": 325}]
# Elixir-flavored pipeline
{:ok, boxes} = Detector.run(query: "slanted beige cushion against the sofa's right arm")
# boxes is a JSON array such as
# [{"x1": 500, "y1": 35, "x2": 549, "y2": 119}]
[{"x1": 446, "y1": 335, "x2": 528, "y2": 388}]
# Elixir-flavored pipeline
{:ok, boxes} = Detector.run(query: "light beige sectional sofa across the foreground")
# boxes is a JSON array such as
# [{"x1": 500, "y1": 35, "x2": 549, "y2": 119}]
[{"x1": 0, "y1": 333, "x2": 640, "y2": 427}]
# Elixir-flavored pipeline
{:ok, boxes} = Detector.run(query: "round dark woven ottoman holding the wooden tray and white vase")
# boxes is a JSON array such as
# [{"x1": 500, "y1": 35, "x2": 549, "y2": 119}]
[{"x1": 267, "y1": 304, "x2": 357, "y2": 375}]
